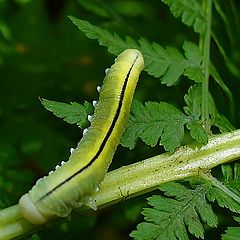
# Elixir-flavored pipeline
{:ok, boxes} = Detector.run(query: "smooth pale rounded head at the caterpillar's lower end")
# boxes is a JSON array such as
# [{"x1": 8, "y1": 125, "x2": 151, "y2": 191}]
[{"x1": 18, "y1": 194, "x2": 46, "y2": 224}]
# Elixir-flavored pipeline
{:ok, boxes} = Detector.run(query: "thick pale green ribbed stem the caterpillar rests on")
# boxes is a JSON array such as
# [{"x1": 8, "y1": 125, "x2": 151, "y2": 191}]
[{"x1": 0, "y1": 130, "x2": 240, "y2": 240}]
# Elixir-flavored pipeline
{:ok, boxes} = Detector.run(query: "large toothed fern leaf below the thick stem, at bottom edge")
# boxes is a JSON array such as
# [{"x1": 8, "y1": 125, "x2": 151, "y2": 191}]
[{"x1": 130, "y1": 182, "x2": 218, "y2": 240}]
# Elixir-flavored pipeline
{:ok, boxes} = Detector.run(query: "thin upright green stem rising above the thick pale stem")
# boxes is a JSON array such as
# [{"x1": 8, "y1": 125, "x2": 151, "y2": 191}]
[{"x1": 200, "y1": 0, "x2": 212, "y2": 133}]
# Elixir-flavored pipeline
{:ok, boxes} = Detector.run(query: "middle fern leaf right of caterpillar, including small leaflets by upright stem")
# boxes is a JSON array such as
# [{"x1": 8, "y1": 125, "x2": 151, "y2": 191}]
[{"x1": 121, "y1": 85, "x2": 214, "y2": 152}]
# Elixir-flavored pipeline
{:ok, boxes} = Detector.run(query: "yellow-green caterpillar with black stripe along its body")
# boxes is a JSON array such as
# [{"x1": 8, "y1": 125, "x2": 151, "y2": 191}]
[{"x1": 19, "y1": 49, "x2": 144, "y2": 224}]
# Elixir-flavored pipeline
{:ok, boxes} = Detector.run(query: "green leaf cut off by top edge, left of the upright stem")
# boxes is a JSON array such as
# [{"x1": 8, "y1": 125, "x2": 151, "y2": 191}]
[{"x1": 162, "y1": 0, "x2": 206, "y2": 33}]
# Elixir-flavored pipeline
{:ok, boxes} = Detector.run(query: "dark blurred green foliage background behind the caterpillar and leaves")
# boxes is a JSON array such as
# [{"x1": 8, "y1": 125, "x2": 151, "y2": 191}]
[{"x1": 0, "y1": 0, "x2": 240, "y2": 240}]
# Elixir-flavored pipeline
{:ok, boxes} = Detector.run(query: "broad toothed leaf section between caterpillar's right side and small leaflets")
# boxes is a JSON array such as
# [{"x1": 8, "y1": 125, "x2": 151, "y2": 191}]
[{"x1": 121, "y1": 100, "x2": 187, "y2": 151}]
